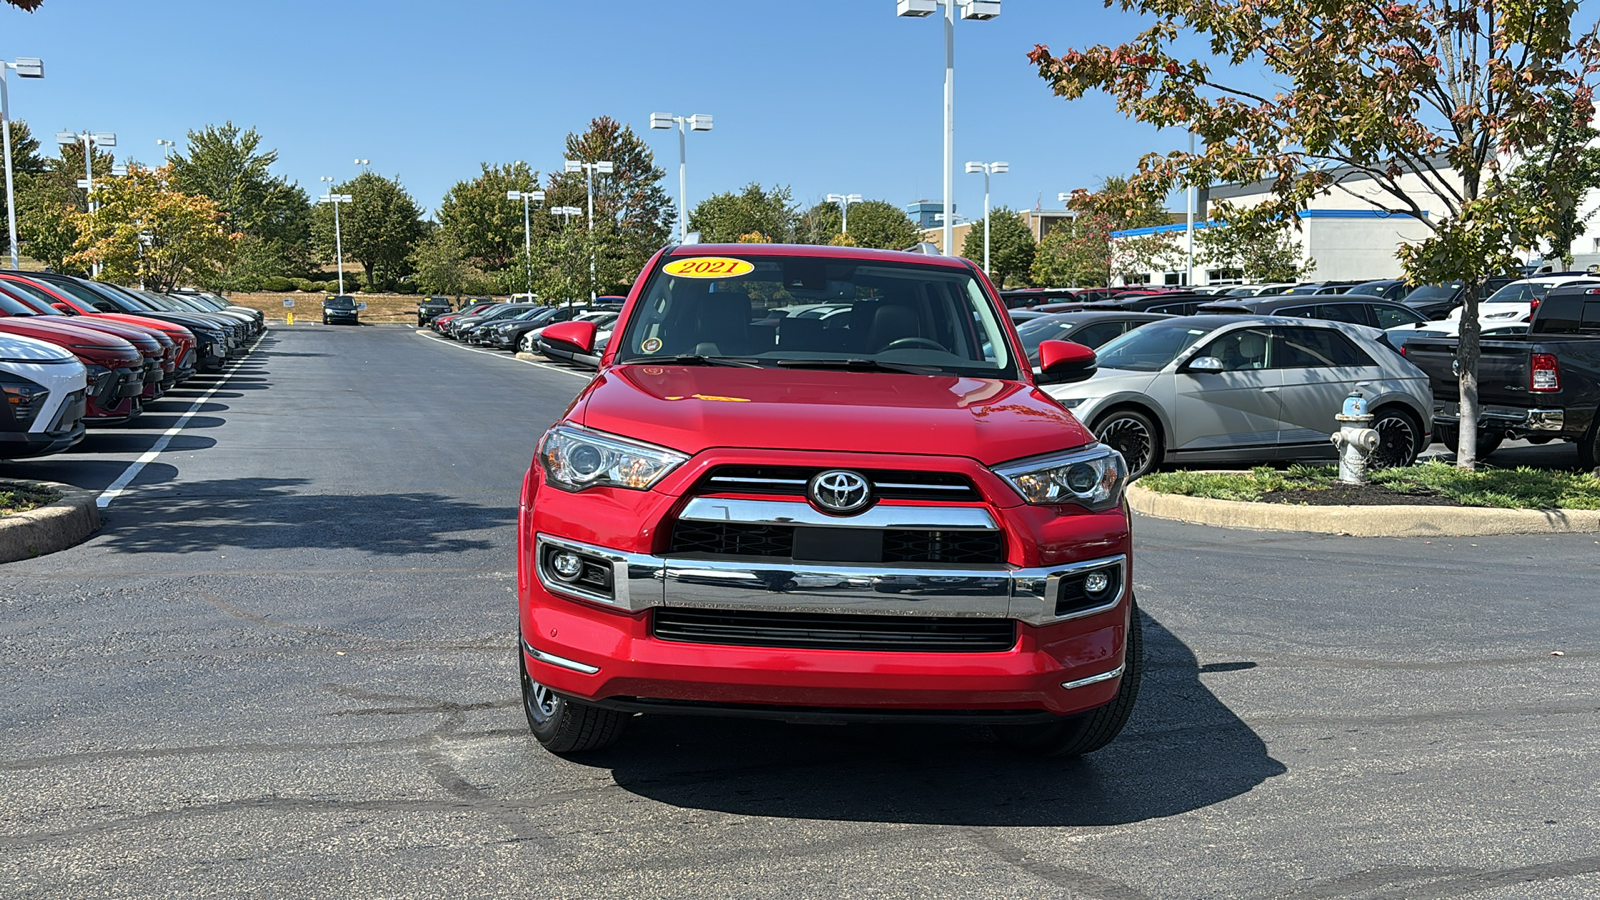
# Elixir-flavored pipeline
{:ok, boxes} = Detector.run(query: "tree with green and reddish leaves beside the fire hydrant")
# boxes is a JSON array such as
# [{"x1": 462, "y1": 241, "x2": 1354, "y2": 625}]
[{"x1": 1029, "y1": 0, "x2": 1600, "y2": 468}]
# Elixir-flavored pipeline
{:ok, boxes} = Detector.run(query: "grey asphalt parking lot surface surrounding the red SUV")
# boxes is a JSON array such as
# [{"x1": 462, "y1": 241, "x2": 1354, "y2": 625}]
[{"x1": 0, "y1": 325, "x2": 1600, "y2": 900}]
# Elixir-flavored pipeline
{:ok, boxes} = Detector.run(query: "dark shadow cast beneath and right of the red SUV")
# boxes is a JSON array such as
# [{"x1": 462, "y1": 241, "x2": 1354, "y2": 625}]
[{"x1": 595, "y1": 605, "x2": 1286, "y2": 826}]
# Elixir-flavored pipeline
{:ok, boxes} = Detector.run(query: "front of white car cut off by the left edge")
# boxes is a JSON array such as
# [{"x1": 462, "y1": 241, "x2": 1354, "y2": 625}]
[{"x1": 0, "y1": 335, "x2": 88, "y2": 460}]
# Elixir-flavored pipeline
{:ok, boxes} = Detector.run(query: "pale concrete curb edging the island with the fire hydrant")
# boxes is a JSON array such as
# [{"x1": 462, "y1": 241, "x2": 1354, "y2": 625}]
[{"x1": 1128, "y1": 484, "x2": 1600, "y2": 538}]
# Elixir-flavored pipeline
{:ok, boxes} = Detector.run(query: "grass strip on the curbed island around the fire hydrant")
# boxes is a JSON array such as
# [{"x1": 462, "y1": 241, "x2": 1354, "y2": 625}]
[{"x1": 1139, "y1": 461, "x2": 1600, "y2": 509}]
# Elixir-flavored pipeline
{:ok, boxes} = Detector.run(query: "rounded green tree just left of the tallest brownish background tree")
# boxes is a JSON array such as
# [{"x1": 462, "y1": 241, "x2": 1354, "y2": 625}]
[{"x1": 438, "y1": 162, "x2": 539, "y2": 273}]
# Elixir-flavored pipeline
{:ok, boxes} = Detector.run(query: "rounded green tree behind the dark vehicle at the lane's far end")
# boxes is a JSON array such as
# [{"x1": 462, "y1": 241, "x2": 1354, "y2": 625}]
[{"x1": 312, "y1": 171, "x2": 427, "y2": 290}]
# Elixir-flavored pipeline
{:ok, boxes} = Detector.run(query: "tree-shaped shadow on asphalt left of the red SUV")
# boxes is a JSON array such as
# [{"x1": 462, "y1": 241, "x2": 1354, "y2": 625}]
[{"x1": 90, "y1": 477, "x2": 517, "y2": 556}]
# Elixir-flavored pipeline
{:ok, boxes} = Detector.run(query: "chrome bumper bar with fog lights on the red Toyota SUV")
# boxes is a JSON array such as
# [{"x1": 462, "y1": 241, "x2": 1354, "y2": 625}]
[{"x1": 534, "y1": 533, "x2": 1130, "y2": 625}]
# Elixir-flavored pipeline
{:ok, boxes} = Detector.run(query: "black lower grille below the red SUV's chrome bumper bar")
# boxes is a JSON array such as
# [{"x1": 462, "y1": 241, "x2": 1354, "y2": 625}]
[{"x1": 651, "y1": 607, "x2": 1016, "y2": 653}]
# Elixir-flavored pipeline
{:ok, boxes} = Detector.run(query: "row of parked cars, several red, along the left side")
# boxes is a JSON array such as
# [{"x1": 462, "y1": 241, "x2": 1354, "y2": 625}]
[{"x1": 0, "y1": 271, "x2": 266, "y2": 458}]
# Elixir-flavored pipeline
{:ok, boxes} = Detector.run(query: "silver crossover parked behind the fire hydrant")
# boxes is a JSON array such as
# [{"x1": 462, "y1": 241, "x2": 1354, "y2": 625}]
[{"x1": 1045, "y1": 315, "x2": 1434, "y2": 477}]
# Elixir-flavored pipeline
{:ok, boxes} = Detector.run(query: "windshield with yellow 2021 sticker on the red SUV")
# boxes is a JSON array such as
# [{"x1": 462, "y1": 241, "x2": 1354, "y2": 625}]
[{"x1": 618, "y1": 255, "x2": 1018, "y2": 378}]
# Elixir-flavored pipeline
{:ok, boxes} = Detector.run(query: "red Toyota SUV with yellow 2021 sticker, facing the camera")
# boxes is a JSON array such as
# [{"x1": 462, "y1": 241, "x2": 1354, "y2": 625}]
[{"x1": 517, "y1": 243, "x2": 1141, "y2": 754}]
